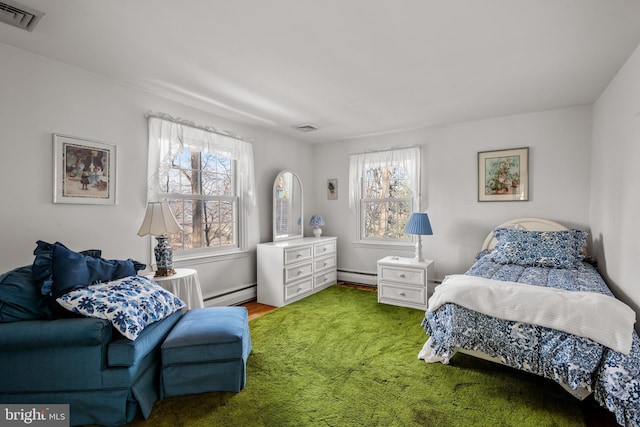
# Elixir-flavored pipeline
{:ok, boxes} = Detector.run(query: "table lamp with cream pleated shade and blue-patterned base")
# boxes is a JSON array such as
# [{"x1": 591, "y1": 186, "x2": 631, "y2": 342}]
[{"x1": 138, "y1": 202, "x2": 182, "y2": 277}]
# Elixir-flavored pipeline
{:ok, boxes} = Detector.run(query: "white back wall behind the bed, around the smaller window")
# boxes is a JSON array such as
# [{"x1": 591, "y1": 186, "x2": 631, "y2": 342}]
[{"x1": 313, "y1": 106, "x2": 591, "y2": 279}]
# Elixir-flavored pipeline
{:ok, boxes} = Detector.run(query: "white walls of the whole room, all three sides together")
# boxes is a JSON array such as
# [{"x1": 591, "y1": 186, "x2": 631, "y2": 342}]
[{"x1": 0, "y1": 39, "x2": 640, "y2": 314}]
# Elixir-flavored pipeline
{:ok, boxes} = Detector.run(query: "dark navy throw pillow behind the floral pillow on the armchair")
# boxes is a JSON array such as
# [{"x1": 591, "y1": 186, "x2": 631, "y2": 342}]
[{"x1": 32, "y1": 240, "x2": 146, "y2": 315}]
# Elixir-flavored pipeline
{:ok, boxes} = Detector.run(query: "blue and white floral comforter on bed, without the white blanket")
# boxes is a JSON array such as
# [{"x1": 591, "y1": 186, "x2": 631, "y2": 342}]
[{"x1": 422, "y1": 253, "x2": 640, "y2": 426}]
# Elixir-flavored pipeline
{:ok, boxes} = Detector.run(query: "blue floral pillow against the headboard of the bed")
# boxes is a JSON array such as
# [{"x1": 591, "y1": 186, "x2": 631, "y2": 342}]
[{"x1": 493, "y1": 228, "x2": 589, "y2": 268}]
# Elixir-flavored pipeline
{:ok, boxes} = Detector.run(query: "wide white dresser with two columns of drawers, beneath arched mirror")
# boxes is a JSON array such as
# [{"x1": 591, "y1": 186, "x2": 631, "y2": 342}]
[{"x1": 257, "y1": 237, "x2": 338, "y2": 307}]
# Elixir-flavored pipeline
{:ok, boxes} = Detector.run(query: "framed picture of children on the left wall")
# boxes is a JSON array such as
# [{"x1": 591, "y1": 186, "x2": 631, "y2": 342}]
[{"x1": 53, "y1": 134, "x2": 116, "y2": 205}]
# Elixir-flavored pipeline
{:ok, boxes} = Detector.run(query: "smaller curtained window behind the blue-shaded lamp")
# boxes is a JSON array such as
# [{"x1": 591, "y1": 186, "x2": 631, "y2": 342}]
[{"x1": 349, "y1": 148, "x2": 420, "y2": 243}]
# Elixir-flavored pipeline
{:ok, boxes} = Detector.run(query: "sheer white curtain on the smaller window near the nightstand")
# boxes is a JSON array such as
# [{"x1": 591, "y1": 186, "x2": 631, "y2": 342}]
[{"x1": 349, "y1": 147, "x2": 420, "y2": 210}]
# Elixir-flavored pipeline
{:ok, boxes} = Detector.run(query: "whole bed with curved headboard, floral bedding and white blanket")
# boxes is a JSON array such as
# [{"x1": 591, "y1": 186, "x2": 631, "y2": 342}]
[{"x1": 418, "y1": 218, "x2": 640, "y2": 426}]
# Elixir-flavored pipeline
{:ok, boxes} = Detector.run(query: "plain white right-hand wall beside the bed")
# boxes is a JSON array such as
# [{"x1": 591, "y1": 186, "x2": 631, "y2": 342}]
[{"x1": 590, "y1": 41, "x2": 640, "y2": 313}]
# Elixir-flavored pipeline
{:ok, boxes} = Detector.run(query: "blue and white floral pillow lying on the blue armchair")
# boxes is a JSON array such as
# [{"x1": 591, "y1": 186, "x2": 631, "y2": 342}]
[{"x1": 56, "y1": 276, "x2": 185, "y2": 340}]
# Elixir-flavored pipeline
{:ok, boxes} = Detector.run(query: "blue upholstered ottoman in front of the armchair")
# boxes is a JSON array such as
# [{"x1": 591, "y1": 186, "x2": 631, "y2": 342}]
[{"x1": 160, "y1": 307, "x2": 251, "y2": 397}]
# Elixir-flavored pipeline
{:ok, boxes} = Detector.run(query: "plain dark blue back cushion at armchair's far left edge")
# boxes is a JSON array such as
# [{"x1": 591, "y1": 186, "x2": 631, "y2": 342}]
[{"x1": 0, "y1": 265, "x2": 44, "y2": 323}]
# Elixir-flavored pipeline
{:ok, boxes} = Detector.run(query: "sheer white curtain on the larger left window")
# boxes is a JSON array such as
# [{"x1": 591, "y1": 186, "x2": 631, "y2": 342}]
[{"x1": 148, "y1": 113, "x2": 256, "y2": 213}]
